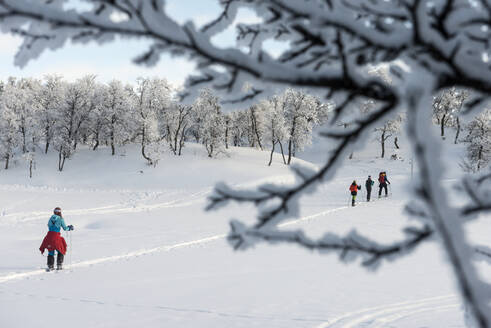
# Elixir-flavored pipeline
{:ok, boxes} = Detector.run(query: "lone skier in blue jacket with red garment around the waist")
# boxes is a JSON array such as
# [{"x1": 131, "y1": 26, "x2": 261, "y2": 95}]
[{"x1": 39, "y1": 207, "x2": 73, "y2": 271}]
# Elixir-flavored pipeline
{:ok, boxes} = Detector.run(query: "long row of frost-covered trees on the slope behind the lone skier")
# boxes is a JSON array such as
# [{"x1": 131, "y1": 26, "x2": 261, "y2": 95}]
[{"x1": 0, "y1": 75, "x2": 330, "y2": 175}]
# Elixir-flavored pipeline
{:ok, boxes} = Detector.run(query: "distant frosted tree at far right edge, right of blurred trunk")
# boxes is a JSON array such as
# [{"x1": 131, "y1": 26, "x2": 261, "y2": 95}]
[{"x1": 464, "y1": 109, "x2": 491, "y2": 172}]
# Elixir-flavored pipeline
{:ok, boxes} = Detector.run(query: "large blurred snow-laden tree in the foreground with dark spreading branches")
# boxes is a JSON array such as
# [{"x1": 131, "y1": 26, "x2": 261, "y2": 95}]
[{"x1": 0, "y1": 0, "x2": 491, "y2": 328}]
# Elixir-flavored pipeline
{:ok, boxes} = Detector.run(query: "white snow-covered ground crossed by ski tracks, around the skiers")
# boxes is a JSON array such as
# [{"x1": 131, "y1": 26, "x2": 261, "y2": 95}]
[{"x1": 0, "y1": 133, "x2": 491, "y2": 328}]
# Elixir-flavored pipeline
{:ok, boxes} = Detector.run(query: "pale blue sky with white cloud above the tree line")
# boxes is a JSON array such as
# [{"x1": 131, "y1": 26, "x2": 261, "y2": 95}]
[{"x1": 0, "y1": 0, "x2": 270, "y2": 85}]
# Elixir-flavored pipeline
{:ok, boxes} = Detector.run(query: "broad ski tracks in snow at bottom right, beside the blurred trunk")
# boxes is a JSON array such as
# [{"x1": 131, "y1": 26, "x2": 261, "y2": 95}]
[{"x1": 315, "y1": 295, "x2": 461, "y2": 328}]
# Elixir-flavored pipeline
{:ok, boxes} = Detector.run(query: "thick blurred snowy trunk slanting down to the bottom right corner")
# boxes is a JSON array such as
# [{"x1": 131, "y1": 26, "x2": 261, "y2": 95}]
[{"x1": 408, "y1": 87, "x2": 491, "y2": 327}]
